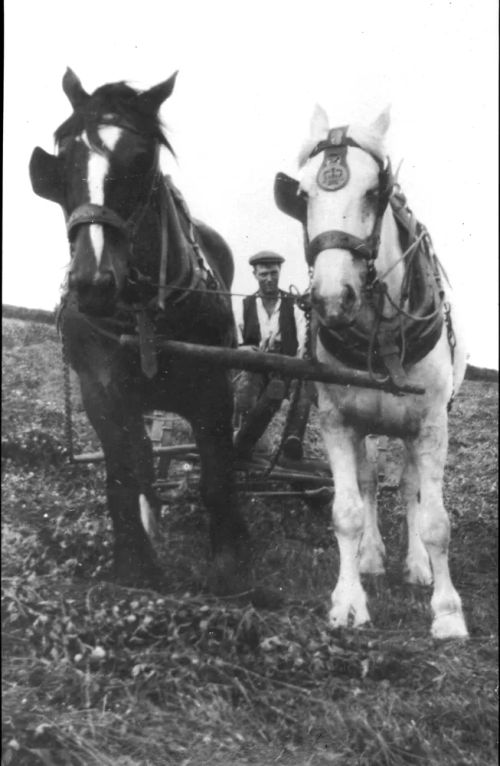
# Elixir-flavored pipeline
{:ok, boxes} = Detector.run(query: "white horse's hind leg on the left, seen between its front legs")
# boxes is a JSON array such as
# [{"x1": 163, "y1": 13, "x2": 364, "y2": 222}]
[{"x1": 358, "y1": 437, "x2": 385, "y2": 575}]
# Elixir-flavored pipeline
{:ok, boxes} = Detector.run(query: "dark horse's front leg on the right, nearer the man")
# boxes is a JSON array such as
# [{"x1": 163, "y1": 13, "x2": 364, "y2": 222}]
[{"x1": 191, "y1": 387, "x2": 250, "y2": 593}]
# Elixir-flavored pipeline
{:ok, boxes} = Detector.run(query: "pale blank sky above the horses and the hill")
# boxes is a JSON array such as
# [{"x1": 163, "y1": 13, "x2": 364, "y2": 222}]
[{"x1": 3, "y1": 0, "x2": 498, "y2": 369}]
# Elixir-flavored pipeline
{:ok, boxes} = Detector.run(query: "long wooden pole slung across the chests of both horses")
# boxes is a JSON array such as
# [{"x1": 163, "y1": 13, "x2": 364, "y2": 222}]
[{"x1": 120, "y1": 335, "x2": 425, "y2": 394}]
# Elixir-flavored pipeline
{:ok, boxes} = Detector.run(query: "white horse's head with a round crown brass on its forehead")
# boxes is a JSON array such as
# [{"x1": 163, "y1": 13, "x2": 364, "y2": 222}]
[{"x1": 299, "y1": 107, "x2": 392, "y2": 329}]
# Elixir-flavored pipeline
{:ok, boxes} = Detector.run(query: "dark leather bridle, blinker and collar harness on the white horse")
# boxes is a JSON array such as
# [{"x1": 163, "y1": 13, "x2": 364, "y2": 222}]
[{"x1": 274, "y1": 126, "x2": 454, "y2": 385}]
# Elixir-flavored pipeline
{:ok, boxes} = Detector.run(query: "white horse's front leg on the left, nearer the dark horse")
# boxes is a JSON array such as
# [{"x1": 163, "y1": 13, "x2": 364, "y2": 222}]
[{"x1": 320, "y1": 413, "x2": 370, "y2": 627}]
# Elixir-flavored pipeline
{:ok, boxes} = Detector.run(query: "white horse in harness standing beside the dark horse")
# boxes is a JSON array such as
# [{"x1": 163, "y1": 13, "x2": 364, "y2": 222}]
[{"x1": 276, "y1": 107, "x2": 467, "y2": 638}]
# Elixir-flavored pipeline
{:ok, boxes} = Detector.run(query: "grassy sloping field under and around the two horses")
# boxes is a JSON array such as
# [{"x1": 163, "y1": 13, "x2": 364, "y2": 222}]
[{"x1": 2, "y1": 320, "x2": 498, "y2": 766}]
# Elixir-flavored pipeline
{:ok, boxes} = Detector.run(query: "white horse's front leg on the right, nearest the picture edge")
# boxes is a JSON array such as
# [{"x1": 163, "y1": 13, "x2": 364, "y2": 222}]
[{"x1": 407, "y1": 413, "x2": 468, "y2": 638}]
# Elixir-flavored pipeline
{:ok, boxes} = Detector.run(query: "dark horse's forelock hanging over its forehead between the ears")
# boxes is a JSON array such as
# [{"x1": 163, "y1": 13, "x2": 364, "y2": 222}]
[{"x1": 54, "y1": 81, "x2": 175, "y2": 156}]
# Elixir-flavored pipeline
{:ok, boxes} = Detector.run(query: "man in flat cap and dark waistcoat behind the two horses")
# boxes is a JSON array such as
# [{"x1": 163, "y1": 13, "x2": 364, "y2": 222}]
[{"x1": 235, "y1": 250, "x2": 309, "y2": 459}]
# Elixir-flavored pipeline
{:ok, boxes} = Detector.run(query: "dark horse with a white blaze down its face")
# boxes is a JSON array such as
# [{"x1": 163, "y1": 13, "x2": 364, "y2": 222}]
[{"x1": 30, "y1": 70, "x2": 249, "y2": 592}]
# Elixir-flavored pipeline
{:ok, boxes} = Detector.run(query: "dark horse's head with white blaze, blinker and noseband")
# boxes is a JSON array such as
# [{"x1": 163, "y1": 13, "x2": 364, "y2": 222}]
[{"x1": 30, "y1": 69, "x2": 177, "y2": 314}]
